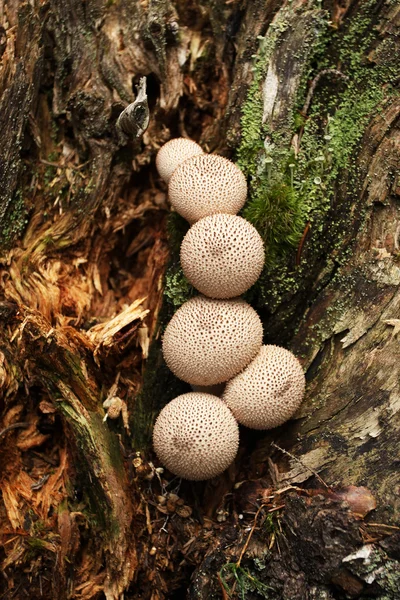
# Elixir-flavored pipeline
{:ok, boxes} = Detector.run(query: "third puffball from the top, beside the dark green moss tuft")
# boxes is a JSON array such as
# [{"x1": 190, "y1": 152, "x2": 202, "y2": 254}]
[{"x1": 181, "y1": 214, "x2": 264, "y2": 298}]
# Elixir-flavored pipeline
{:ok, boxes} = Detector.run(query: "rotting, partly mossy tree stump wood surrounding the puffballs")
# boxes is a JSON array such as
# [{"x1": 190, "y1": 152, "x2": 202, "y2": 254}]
[{"x1": 0, "y1": 0, "x2": 400, "y2": 600}]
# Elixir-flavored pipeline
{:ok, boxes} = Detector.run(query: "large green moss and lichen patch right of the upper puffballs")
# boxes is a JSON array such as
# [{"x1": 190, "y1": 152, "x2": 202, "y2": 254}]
[{"x1": 237, "y1": 0, "x2": 398, "y2": 320}]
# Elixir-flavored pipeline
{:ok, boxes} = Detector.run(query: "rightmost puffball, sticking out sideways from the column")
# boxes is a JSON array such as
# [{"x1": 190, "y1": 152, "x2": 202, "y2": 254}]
[{"x1": 222, "y1": 346, "x2": 306, "y2": 429}]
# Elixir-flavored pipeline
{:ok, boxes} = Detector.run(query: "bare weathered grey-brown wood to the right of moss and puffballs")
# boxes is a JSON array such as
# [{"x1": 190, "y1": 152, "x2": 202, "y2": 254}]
[{"x1": 262, "y1": 99, "x2": 400, "y2": 519}]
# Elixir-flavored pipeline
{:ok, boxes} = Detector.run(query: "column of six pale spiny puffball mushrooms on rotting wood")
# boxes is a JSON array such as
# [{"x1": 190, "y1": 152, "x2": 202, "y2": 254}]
[{"x1": 153, "y1": 138, "x2": 305, "y2": 480}]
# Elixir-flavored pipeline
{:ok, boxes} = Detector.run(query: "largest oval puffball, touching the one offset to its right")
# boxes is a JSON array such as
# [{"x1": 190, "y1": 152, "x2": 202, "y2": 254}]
[{"x1": 163, "y1": 296, "x2": 263, "y2": 385}]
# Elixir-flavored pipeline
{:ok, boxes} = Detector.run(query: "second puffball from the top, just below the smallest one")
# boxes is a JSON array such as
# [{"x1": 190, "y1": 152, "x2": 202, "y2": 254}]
[{"x1": 168, "y1": 154, "x2": 247, "y2": 223}]
